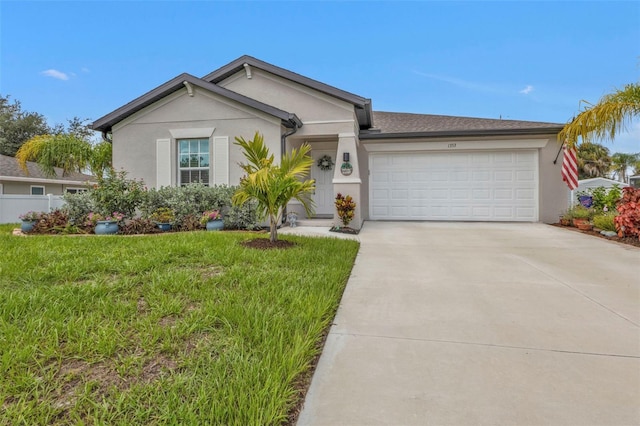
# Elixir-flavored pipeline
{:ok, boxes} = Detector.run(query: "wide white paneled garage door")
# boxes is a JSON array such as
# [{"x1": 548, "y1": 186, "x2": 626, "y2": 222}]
[{"x1": 369, "y1": 150, "x2": 538, "y2": 222}]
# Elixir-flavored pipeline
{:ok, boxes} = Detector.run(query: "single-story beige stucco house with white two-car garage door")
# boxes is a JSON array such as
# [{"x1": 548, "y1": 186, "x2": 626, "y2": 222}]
[{"x1": 93, "y1": 56, "x2": 568, "y2": 227}]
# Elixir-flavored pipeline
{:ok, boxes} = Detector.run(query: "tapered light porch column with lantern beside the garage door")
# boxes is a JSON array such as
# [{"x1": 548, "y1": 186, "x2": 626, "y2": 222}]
[{"x1": 333, "y1": 133, "x2": 362, "y2": 229}]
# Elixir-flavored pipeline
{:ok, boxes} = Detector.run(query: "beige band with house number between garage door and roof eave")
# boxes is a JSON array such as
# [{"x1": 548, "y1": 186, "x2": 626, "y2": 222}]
[{"x1": 362, "y1": 139, "x2": 549, "y2": 152}]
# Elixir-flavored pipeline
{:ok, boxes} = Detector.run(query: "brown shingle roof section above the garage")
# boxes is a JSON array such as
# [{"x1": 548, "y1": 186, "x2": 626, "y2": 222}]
[{"x1": 373, "y1": 111, "x2": 564, "y2": 133}]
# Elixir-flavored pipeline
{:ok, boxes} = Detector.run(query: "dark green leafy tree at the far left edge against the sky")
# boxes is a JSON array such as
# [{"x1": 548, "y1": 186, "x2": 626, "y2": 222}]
[{"x1": 0, "y1": 95, "x2": 51, "y2": 157}]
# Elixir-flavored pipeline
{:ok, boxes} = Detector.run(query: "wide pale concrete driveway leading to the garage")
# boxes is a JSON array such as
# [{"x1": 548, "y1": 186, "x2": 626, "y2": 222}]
[{"x1": 298, "y1": 222, "x2": 640, "y2": 426}]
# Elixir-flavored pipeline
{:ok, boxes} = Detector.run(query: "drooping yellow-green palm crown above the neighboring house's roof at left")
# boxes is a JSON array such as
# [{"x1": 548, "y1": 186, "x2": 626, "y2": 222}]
[{"x1": 16, "y1": 133, "x2": 112, "y2": 179}]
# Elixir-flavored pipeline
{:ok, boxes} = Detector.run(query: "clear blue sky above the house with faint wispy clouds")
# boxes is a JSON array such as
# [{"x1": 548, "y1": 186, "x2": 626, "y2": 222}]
[{"x1": 0, "y1": 0, "x2": 640, "y2": 152}]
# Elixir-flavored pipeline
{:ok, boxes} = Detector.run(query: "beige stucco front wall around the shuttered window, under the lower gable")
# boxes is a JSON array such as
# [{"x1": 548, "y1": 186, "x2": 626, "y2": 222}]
[{"x1": 113, "y1": 90, "x2": 282, "y2": 187}]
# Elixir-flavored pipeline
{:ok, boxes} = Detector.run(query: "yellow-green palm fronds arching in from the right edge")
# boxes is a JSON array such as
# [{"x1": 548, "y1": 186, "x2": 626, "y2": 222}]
[{"x1": 558, "y1": 83, "x2": 640, "y2": 146}]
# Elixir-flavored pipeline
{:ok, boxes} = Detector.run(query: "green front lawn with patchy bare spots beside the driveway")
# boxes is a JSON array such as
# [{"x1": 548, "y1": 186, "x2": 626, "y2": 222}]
[{"x1": 0, "y1": 225, "x2": 358, "y2": 425}]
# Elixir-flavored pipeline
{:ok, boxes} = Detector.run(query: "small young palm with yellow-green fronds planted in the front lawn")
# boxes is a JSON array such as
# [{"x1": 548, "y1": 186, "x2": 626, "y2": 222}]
[{"x1": 232, "y1": 132, "x2": 316, "y2": 243}]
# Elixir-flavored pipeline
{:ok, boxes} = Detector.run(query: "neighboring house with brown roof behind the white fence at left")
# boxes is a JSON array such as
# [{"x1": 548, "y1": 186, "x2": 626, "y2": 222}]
[{"x1": 0, "y1": 155, "x2": 95, "y2": 195}]
